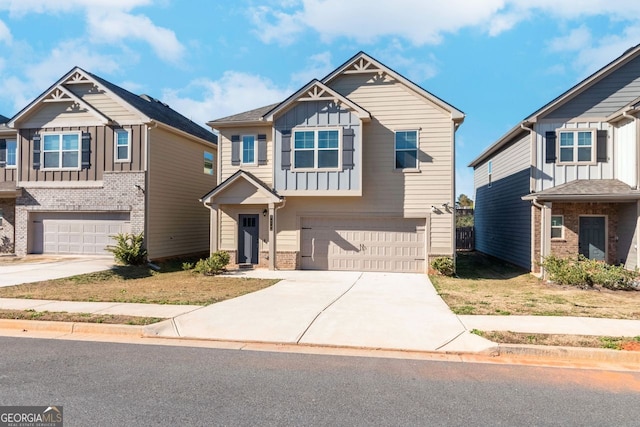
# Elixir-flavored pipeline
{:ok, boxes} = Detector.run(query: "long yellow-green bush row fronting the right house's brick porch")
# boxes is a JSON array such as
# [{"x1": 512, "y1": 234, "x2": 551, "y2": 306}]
[{"x1": 541, "y1": 255, "x2": 636, "y2": 290}]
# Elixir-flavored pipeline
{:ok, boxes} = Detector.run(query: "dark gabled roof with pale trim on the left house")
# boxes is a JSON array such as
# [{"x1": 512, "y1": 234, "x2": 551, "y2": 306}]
[{"x1": 9, "y1": 67, "x2": 217, "y2": 144}]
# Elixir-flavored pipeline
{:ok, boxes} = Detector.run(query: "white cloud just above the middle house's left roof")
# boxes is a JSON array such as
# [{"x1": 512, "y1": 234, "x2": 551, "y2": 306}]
[{"x1": 162, "y1": 71, "x2": 291, "y2": 124}]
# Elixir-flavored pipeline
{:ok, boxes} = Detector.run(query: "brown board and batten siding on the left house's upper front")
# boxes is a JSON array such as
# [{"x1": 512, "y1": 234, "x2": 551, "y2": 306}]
[{"x1": 18, "y1": 125, "x2": 145, "y2": 182}]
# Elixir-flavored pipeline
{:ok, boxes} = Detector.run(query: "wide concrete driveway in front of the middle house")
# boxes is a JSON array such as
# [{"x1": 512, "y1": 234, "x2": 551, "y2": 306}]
[{"x1": 147, "y1": 270, "x2": 494, "y2": 351}]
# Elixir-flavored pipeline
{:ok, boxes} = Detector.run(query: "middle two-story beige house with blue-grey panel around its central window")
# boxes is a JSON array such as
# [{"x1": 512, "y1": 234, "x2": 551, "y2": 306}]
[{"x1": 202, "y1": 52, "x2": 464, "y2": 272}]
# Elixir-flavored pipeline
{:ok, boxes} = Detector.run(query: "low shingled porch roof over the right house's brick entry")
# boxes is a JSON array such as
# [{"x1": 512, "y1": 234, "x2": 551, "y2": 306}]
[{"x1": 522, "y1": 179, "x2": 640, "y2": 201}]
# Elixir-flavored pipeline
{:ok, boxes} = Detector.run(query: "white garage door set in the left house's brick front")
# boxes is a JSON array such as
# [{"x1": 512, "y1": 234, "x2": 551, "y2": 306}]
[{"x1": 31, "y1": 212, "x2": 130, "y2": 255}]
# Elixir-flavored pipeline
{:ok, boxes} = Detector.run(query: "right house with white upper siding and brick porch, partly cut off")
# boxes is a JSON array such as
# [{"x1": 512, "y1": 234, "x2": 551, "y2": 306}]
[{"x1": 469, "y1": 45, "x2": 640, "y2": 271}]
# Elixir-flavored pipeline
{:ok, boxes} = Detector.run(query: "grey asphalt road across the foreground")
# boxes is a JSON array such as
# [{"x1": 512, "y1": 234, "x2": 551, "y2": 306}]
[{"x1": 0, "y1": 337, "x2": 640, "y2": 427}]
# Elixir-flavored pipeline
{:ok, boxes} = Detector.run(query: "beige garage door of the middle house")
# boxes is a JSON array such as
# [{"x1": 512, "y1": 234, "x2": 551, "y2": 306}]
[{"x1": 302, "y1": 218, "x2": 426, "y2": 273}]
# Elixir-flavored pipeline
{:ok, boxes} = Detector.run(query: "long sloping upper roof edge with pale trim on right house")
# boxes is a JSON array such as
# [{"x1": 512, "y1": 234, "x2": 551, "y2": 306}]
[{"x1": 469, "y1": 44, "x2": 640, "y2": 167}]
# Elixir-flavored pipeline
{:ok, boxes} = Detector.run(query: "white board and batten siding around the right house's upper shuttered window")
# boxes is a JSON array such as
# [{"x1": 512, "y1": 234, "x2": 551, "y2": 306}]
[{"x1": 534, "y1": 121, "x2": 614, "y2": 192}]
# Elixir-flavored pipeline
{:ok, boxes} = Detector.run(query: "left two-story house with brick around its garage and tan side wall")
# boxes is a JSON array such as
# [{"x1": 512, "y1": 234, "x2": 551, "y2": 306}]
[{"x1": 0, "y1": 67, "x2": 217, "y2": 259}]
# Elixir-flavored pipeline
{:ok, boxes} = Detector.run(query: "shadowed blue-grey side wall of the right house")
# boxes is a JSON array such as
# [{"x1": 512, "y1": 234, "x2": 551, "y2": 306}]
[{"x1": 474, "y1": 133, "x2": 531, "y2": 269}]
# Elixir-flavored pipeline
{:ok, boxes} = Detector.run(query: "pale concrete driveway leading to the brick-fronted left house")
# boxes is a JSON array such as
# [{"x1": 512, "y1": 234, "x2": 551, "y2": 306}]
[{"x1": 0, "y1": 256, "x2": 114, "y2": 287}]
